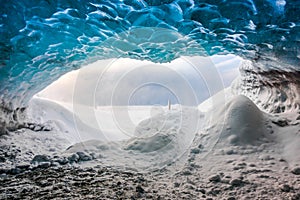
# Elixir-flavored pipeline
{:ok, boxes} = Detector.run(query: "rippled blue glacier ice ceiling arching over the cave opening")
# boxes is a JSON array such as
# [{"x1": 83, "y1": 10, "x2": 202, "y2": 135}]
[{"x1": 0, "y1": 0, "x2": 300, "y2": 108}]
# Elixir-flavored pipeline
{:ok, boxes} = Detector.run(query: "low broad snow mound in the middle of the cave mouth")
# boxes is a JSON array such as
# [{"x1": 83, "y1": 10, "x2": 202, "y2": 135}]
[{"x1": 65, "y1": 107, "x2": 203, "y2": 171}]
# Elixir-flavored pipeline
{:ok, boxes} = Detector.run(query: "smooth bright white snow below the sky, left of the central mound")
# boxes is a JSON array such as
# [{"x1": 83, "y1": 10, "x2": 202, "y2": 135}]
[{"x1": 27, "y1": 96, "x2": 163, "y2": 144}]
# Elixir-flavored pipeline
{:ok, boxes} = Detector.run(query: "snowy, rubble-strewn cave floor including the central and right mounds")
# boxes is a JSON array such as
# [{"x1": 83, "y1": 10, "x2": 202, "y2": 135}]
[{"x1": 0, "y1": 89, "x2": 300, "y2": 200}]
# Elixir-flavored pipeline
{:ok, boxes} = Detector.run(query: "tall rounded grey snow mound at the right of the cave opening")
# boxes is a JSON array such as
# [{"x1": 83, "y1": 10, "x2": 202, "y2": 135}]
[{"x1": 207, "y1": 95, "x2": 268, "y2": 145}]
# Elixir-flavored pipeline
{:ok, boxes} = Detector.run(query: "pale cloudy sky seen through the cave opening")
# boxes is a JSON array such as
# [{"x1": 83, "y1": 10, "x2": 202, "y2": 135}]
[{"x1": 36, "y1": 55, "x2": 242, "y2": 106}]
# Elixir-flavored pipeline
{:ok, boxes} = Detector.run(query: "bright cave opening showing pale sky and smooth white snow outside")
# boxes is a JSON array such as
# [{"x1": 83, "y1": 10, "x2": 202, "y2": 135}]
[{"x1": 29, "y1": 54, "x2": 242, "y2": 143}]
